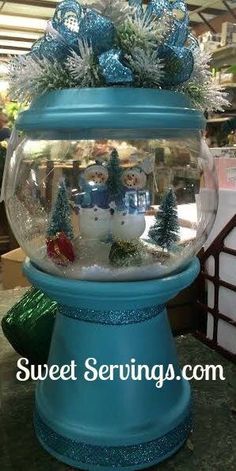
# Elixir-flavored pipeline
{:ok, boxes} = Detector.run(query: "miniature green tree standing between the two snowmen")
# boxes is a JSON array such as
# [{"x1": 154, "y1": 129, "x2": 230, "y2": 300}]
[{"x1": 107, "y1": 149, "x2": 123, "y2": 206}]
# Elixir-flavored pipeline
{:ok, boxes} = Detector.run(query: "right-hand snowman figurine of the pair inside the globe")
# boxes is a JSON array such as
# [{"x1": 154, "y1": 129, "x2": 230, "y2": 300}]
[{"x1": 112, "y1": 167, "x2": 150, "y2": 240}]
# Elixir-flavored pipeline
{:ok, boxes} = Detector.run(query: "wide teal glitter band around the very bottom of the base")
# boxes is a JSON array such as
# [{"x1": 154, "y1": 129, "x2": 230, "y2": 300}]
[{"x1": 34, "y1": 412, "x2": 192, "y2": 468}]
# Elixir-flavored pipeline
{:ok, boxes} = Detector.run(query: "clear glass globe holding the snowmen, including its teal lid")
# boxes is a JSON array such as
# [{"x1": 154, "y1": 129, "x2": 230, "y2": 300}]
[{"x1": 4, "y1": 89, "x2": 217, "y2": 281}]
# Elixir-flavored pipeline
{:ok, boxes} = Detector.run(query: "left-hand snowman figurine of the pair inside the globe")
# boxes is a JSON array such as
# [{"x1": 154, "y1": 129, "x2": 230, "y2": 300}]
[{"x1": 76, "y1": 164, "x2": 111, "y2": 241}]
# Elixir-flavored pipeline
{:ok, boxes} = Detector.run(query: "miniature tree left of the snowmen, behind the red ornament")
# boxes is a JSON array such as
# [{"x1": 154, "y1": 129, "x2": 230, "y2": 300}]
[{"x1": 47, "y1": 181, "x2": 74, "y2": 240}]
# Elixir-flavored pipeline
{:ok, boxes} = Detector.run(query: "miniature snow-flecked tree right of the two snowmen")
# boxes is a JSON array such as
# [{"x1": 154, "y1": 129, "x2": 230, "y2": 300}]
[{"x1": 148, "y1": 189, "x2": 179, "y2": 250}]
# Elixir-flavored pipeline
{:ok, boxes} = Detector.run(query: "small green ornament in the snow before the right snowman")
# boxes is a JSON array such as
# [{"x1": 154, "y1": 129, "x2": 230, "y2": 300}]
[{"x1": 109, "y1": 240, "x2": 143, "y2": 267}]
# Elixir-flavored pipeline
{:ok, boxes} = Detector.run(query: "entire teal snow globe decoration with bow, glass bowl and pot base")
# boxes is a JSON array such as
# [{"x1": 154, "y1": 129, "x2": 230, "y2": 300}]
[{"x1": 3, "y1": 0, "x2": 223, "y2": 470}]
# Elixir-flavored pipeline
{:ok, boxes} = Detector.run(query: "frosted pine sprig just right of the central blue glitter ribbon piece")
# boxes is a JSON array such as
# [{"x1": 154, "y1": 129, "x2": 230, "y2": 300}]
[{"x1": 125, "y1": 47, "x2": 164, "y2": 88}]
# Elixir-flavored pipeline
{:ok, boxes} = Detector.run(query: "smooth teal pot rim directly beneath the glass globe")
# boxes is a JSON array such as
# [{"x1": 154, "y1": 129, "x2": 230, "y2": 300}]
[{"x1": 23, "y1": 257, "x2": 200, "y2": 310}]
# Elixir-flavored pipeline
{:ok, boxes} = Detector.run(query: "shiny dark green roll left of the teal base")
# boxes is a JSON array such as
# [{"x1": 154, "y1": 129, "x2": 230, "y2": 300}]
[{"x1": 2, "y1": 288, "x2": 57, "y2": 365}]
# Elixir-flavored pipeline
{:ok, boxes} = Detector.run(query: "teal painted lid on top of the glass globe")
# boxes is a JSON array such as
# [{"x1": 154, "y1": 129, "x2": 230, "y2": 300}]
[{"x1": 16, "y1": 88, "x2": 205, "y2": 139}]
